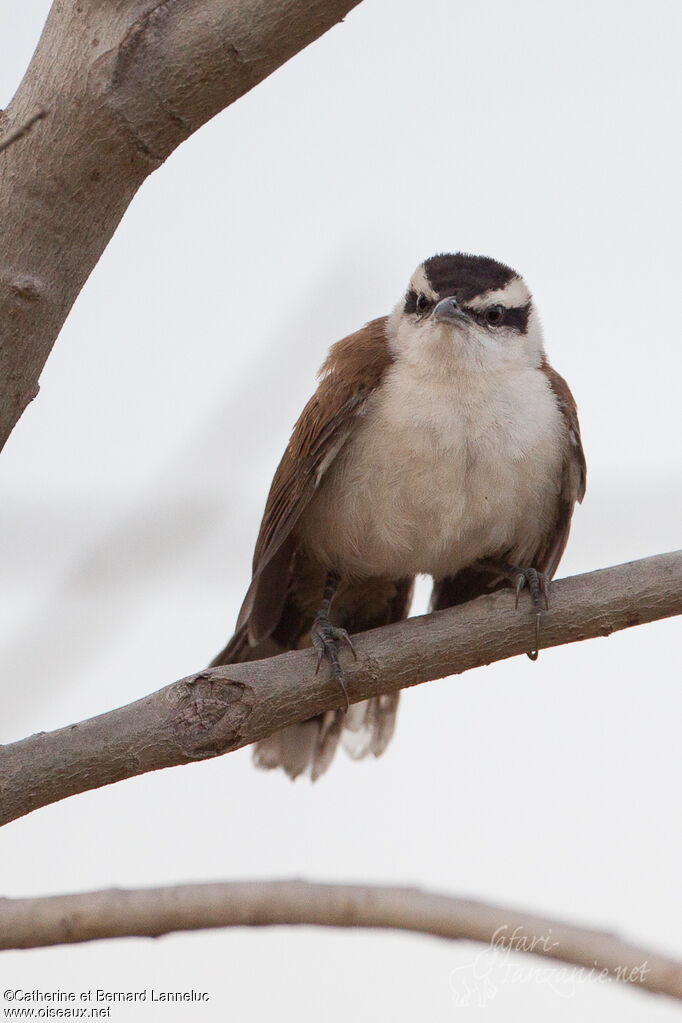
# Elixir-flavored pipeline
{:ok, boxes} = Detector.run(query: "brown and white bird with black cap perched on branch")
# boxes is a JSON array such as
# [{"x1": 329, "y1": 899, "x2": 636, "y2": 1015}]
[{"x1": 212, "y1": 252, "x2": 586, "y2": 781}]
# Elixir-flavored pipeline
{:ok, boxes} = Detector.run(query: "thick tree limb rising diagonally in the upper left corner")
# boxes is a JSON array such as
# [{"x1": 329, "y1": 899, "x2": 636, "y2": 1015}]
[{"x1": 0, "y1": 0, "x2": 359, "y2": 449}]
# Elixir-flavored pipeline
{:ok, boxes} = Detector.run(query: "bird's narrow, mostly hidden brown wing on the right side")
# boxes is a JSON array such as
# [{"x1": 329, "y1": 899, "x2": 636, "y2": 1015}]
[{"x1": 430, "y1": 361, "x2": 587, "y2": 611}]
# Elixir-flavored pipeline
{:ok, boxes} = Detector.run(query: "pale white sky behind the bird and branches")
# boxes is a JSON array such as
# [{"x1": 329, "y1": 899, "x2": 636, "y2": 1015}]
[{"x1": 0, "y1": 0, "x2": 682, "y2": 1023}]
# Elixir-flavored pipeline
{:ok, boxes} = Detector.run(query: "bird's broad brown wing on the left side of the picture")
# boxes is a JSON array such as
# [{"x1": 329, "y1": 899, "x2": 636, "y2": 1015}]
[{"x1": 237, "y1": 317, "x2": 392, "y2": 644}]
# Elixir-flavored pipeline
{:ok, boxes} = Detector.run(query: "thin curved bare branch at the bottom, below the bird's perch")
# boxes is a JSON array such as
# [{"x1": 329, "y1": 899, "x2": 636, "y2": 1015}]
[{"x1": 0, "y1": 881, "x2": 682, "y2": 999}]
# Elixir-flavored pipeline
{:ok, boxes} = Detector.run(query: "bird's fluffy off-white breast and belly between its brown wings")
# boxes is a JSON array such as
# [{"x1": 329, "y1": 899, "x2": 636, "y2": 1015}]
[{"x1": 300, "y1": 360, "x2": 566, "y2": 578}]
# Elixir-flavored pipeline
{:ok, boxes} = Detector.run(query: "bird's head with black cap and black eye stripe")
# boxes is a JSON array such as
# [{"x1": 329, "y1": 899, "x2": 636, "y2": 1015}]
[{"x1": 389, "y1": 253, "x2": 544, "y2": 371}]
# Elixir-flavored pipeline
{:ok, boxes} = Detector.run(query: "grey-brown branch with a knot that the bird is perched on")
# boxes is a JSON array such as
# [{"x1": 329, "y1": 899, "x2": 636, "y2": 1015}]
[{"x1": 0, "y1": 551, "x2": 682, "y2": 824}]
